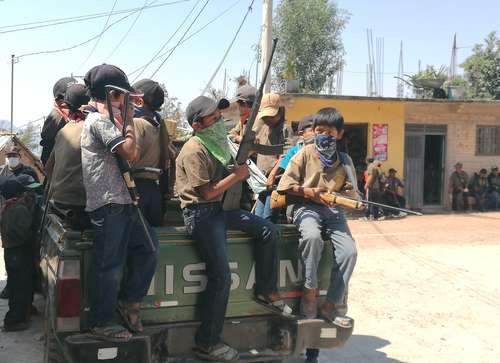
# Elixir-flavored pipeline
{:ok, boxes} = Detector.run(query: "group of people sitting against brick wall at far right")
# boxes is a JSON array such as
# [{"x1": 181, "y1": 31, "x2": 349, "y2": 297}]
[{"x1": 450, "y1": 162, "x2": 500, "y2": 212}]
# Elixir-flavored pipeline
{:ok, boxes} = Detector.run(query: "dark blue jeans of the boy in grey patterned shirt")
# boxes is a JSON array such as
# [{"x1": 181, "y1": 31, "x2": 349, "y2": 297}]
[{"x1": 90, "y1": 204, "x2": 158, "y2": 327}]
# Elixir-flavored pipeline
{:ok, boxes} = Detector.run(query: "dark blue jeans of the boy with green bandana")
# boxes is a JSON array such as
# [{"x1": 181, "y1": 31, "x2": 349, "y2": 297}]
[{"x1": 183, "y1": 203, "x2": 278, "y2": 348}]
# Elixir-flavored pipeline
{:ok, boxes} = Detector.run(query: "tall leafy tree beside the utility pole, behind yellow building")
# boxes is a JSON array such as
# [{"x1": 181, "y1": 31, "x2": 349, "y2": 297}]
[{"x1": 274, "y1": 0, "x2": 348, "y2": 93}]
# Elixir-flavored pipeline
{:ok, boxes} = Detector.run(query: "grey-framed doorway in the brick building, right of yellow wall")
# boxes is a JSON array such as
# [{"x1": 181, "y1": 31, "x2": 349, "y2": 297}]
[{"x1": 405, "y1": 124, "x2": 446, "y2": 209}]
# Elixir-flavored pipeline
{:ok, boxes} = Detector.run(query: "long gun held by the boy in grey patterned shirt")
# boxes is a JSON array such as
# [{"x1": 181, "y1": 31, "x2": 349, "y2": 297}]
[{"x1": 104, "y1": 85, "x2": 156, "y2": 252}]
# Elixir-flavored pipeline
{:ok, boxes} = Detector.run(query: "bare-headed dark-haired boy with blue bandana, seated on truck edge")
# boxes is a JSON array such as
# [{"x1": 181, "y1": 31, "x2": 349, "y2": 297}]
[{"x1": 277, "y1": 108, "x2": 358, "y2": 321}]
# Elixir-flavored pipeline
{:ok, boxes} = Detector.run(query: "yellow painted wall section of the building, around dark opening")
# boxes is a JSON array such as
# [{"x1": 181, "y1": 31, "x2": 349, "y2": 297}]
[{"x1": 283, "y1": 94, "x2": 405, "y2": 177}]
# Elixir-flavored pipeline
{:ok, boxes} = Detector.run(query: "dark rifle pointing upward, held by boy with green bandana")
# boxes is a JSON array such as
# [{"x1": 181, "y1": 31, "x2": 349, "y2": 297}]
[{"x1": 235, "y1": 38, "x2": 283, "y2": 165}]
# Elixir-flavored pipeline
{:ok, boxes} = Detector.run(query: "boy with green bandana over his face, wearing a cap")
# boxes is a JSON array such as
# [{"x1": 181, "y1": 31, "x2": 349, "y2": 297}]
[{"x1": 176, "y1": 96, "x2": 283, "y2": 362}]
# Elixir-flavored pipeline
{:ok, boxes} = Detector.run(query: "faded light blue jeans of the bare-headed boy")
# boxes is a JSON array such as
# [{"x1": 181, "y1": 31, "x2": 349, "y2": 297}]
[{"x1": 287, "y1": 202, "x2": 357, "y2": 305}]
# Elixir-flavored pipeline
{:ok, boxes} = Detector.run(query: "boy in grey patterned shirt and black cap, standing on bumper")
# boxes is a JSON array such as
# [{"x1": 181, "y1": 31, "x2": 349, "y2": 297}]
[{"x1": 81, "y1": 64, "x2": 158, "y2": 342}]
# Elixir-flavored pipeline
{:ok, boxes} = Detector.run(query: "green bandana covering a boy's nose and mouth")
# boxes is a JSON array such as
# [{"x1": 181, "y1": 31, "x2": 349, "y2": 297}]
[{"x1": 195, "y1": 117, "x2": 231, "y2": 166}]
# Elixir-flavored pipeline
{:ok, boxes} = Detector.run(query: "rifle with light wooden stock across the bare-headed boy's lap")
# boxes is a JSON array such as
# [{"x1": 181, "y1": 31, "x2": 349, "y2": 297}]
[{"x1": 271, "y1": 191, "x2": 423, "y2": 216}]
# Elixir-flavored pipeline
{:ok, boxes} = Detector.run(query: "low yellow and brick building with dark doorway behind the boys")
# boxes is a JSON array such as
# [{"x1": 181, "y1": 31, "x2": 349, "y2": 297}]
[{"x1": 283, "y1": 94, "x2": 500, "y2": 209}]
